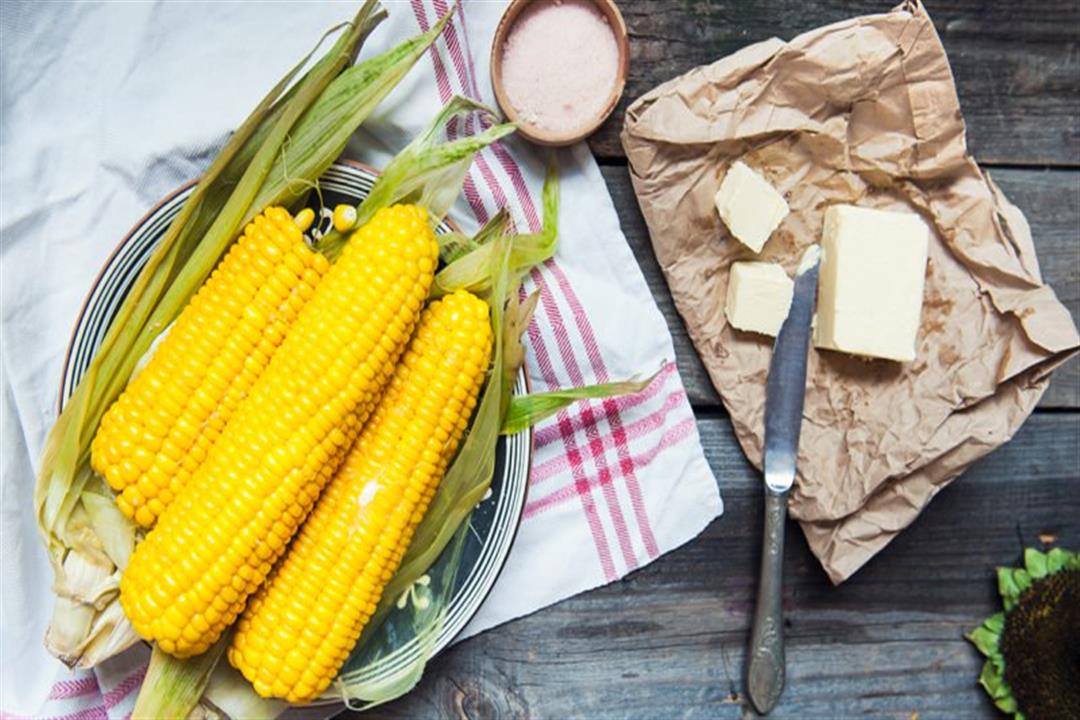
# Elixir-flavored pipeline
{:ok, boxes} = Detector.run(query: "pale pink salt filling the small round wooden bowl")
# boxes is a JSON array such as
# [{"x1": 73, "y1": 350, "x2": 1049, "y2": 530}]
[{"x1": 502, "y1": 0, "x2": 619, "y2": 134}]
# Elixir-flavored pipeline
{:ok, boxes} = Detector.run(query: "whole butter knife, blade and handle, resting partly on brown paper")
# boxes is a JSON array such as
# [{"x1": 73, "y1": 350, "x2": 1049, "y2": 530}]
[{"x1": 746, "y1": 245, "x2": 821, "y2": 715}]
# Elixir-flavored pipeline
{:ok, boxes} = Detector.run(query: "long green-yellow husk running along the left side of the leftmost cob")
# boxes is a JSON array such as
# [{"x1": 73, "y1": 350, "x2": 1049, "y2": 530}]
[{"x1": 35, "y1": 0, "x2": 455, "y2": 667}]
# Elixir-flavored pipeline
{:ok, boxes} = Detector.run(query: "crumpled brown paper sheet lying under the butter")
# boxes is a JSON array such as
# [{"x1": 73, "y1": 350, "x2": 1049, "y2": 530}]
[{"x1": 622, "y1": 2, "x2": 1080, "y2": 583}]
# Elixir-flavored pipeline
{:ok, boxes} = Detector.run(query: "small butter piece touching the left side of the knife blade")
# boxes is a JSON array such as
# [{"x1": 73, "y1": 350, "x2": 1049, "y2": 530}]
[{"x1": 724, "y1": 262, "x2": 795, "y2": 337}]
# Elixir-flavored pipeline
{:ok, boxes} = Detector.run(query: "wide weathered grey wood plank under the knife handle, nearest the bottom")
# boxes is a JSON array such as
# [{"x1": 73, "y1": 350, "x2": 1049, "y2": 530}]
[{"x1": 364, "y1": 413, "x2": 1080, "y2": 720}]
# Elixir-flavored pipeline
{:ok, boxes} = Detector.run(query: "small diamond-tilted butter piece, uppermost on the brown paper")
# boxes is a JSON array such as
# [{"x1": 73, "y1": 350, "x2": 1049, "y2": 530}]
[{"x1": 716, "y1": 162, "x2": 788, "y2": 253}]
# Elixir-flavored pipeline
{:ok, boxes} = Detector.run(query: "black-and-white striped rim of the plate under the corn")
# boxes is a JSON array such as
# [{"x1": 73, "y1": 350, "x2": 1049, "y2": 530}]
[{"x1": 56, "y1": 160, "x2": 536, "y2": 706}]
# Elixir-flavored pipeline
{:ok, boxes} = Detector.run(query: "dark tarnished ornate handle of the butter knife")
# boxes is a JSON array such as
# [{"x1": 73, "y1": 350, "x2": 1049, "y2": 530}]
[{"x1": 746, "y1": 490, "x2": 787, "y2": 715}]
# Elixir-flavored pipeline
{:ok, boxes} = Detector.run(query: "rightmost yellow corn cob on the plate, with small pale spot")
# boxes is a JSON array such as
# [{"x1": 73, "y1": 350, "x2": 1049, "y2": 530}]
[{"x1": 229, "y1": 290, "x2": 491, "y2": 703}]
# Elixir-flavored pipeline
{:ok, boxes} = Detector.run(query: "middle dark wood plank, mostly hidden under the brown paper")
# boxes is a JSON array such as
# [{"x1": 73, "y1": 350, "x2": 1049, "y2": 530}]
[{"x1": 602, "y1": 165, "x2": 1080, "y2": 408}]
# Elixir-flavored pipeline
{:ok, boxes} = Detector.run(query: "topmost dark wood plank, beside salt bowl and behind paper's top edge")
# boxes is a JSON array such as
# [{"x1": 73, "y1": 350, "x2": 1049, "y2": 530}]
[{"x1": 591, "y1": 0, "x2": 1080, "y2": 165}]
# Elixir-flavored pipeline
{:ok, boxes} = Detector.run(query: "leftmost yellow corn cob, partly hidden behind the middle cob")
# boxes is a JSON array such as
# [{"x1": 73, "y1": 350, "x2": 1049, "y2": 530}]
[{"x1": 91, "y1": 207, "x2": 329, "y2": 527}]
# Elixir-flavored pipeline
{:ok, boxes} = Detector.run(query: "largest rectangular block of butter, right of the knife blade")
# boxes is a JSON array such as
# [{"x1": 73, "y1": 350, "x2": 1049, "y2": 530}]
[{"x1": 814, "y1": 205, "x2": 930, "y2": 362}]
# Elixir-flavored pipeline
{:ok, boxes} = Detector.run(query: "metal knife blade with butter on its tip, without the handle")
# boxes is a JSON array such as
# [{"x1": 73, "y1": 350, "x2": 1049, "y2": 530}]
[{"x1": 765, "y1": 245, "x2": 821, "y2": 492}]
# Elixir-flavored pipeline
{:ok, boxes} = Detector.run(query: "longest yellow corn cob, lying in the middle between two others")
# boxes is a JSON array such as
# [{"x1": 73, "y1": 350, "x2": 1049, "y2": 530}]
[{"x1": 120, "y1": 205, "x2": 438, "y2": 657}]
